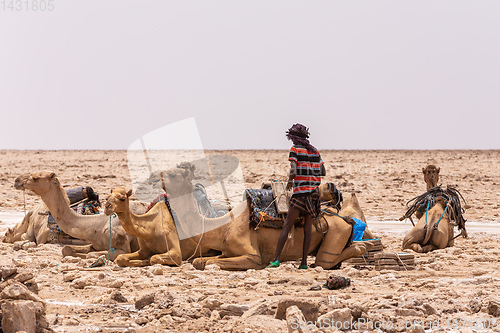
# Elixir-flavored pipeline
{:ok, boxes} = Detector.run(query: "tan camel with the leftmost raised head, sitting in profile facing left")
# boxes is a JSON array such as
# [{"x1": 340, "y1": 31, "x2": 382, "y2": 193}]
[{"x1": 14, "y1": 171, "x2": 138, "y2": 260}]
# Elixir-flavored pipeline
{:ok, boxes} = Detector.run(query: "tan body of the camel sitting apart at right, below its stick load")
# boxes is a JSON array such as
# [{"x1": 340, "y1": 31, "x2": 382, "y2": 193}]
[{"x1": 403, "y1": 198, "x2": 454, "y2": 253}]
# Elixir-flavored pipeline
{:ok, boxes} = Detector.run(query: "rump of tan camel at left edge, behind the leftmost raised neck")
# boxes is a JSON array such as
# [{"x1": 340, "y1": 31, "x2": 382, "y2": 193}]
[{"x1": 2, "y1": 203, "x2": 50, "y2": 244}]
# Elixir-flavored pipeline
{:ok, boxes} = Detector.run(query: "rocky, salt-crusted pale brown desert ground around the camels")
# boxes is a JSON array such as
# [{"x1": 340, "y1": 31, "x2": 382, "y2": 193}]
[{"x1": 0, "y1": 150, "x2": 500, "y2": 332}]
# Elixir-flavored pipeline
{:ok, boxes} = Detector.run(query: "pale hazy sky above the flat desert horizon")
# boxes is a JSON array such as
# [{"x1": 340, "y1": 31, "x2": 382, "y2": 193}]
[{"x1": 0, "y1": 0, "x2": 500, "y2": 149}]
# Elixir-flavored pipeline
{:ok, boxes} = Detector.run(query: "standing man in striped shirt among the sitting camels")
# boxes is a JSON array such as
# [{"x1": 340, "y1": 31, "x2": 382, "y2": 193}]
[{"x1": 269, "y1": 124, "x2": 326, "y2": 269}]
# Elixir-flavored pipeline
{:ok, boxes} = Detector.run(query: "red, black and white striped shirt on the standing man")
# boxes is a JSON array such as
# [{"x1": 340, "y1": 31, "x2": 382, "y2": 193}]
[{"x1": 288, "y1": 145, "x2": 324, "y2": 196}]
